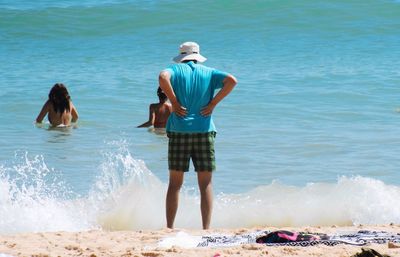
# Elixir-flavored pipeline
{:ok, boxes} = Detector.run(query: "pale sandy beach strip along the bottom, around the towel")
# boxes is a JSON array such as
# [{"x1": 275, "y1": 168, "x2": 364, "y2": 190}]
[{"x1": 0, "y1": 225, "x2": 400, "y2": 257}]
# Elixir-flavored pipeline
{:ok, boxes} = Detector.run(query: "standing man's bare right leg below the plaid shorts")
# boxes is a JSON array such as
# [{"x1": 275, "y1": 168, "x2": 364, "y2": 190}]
[{"x1": 197, "y1": 171, "x2": 213, "y2": 229}]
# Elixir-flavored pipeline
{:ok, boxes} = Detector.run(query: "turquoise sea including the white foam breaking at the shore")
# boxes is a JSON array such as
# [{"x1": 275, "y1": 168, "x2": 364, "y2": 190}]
[{"x1": 0, "y1": 0, "x2": 400, "y2": 231}]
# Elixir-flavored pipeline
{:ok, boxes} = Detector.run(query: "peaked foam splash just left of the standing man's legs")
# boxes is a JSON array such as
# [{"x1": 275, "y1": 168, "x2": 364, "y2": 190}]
[{"x1": 89, "y1": 142, "x2": 165, "y2": 229}]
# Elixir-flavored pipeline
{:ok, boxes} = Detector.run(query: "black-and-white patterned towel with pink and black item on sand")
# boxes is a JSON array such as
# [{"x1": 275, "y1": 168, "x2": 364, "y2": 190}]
[{"x1": 197, "y1": 230, "x2": 400, "y2": 247}]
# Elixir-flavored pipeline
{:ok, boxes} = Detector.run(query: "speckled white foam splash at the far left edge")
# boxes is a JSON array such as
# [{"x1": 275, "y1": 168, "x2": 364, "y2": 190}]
[{"x1": 0, "y1": 154, "x2": 94, "y2": 234}]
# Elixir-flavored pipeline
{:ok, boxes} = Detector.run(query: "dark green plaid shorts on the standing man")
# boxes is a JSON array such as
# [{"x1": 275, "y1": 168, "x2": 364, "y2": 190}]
[{"x1": 167, "y1": 131, "x2": 216, "y2": 172}]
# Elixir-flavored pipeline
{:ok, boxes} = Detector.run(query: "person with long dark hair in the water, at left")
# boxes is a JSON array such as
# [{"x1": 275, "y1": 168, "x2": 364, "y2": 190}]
[{"x1": 36, "y1": 83, "x2": 78, "y2": 126}]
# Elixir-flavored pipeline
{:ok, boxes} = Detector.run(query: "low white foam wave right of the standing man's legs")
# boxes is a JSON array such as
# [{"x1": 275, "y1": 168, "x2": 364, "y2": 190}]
[{"x1": 215, "y1": 176, "x2": 400, "y2": 227}]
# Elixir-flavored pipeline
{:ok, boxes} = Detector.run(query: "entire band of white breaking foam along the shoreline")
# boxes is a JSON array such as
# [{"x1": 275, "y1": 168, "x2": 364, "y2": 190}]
[{"x1": 0, "y1": 149, "x2": 400, "y2": 234}]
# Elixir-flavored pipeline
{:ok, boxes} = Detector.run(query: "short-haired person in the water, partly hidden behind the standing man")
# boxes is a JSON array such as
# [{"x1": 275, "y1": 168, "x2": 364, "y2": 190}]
[{"x1": 138, "y1": 87, "x2": 172, "y2": 128}]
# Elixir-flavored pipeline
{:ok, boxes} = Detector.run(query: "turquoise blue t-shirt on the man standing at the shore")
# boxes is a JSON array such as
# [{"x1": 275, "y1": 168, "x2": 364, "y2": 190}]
[{"x1": 166, "y1": 62, "x2": 228, "y2": 133}]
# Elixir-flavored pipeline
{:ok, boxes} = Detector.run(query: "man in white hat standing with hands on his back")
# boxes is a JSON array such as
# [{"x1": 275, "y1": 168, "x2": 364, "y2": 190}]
[{"x1": 159, "y1": 42, "x2": 237, "y2": 229}]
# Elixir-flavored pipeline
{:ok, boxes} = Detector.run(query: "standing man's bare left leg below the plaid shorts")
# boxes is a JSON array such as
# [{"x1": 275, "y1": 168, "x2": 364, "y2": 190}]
[{"x1": 166, "y1": 170, "x2": 184, "y2": 228}]
